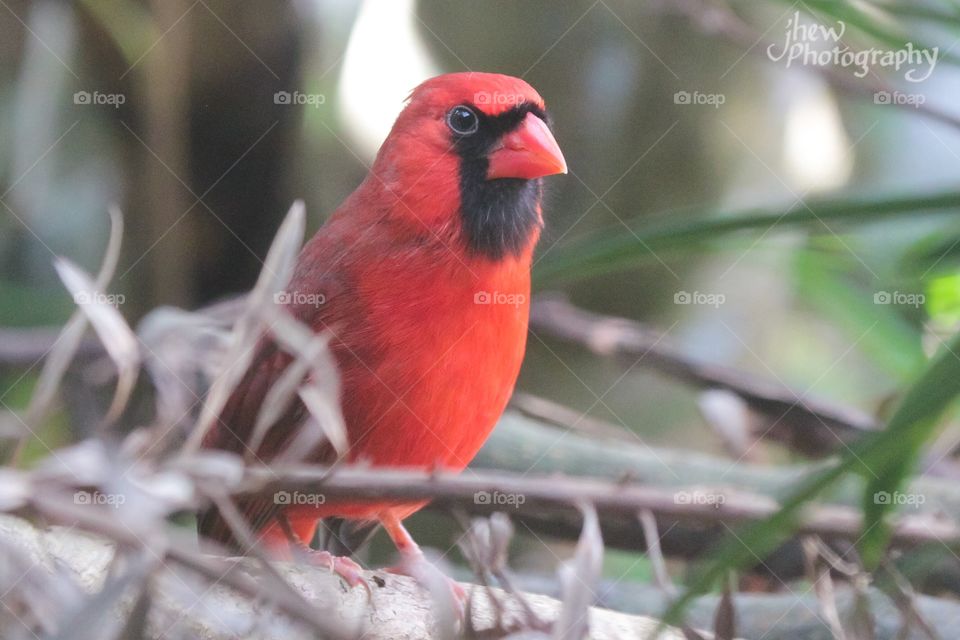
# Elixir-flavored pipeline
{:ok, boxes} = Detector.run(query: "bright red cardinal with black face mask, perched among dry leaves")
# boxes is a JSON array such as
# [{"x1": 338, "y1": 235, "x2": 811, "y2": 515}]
[{"x1": 199, "y1": 72, "x2": 566, "y2": 579}]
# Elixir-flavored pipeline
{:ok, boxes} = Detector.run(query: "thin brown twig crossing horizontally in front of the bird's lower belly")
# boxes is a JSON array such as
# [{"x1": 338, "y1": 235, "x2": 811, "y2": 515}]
[{"x1": 216, "y1": 465, "x2": 960, "y2": 547}]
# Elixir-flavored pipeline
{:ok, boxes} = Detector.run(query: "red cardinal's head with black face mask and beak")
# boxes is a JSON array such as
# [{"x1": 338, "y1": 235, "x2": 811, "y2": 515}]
[{"x1": 373, "y1": 72, "x2": 567, "y2": 260}]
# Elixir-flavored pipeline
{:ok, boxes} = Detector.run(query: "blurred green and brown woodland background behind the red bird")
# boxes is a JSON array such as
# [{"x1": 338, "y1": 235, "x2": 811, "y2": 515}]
[{"x1": 0, "y1": 0, "x2": 960, "y2": 600}]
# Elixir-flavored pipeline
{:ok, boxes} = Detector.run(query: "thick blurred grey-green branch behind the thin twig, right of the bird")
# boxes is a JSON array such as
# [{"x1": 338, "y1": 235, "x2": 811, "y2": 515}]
[{"x1": 476, "y1": 412, "x2": 960, "y2": 588}]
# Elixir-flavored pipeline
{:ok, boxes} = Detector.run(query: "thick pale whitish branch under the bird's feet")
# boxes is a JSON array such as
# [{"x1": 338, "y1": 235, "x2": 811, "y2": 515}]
[{"x1": 0, "y1": 506, "x2": 684, "y2": 640}]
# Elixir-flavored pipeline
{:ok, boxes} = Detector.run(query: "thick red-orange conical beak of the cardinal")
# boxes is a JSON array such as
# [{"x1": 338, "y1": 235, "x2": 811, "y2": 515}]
[{"x1": 487, "y1": 113, "x2": 567, "y2": 180}]
